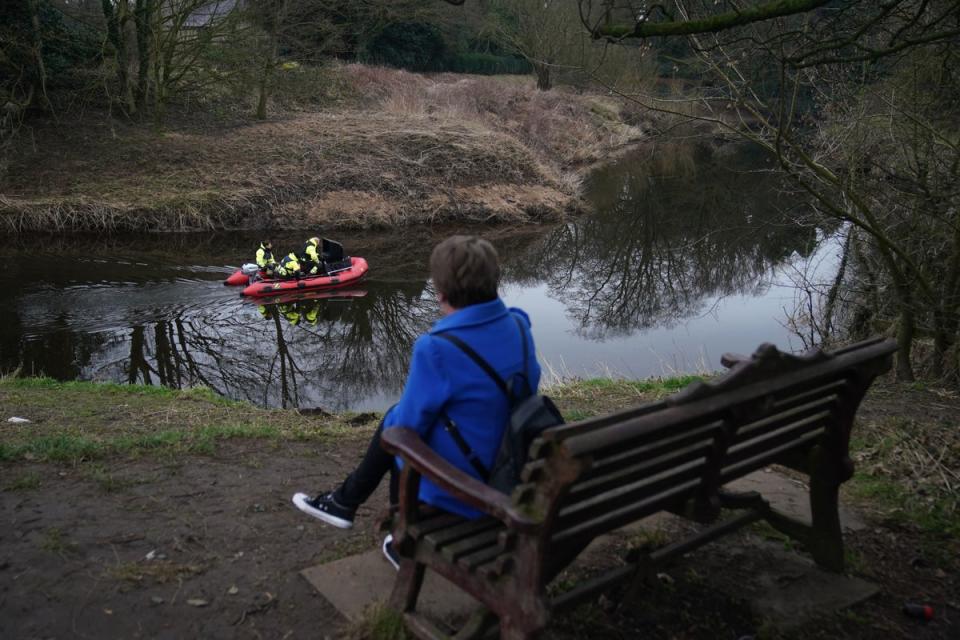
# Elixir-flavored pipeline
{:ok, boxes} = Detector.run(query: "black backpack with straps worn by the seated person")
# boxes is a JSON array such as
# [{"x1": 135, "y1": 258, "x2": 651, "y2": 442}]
[{"x1": 434, "y1": 314, "x2": 563, "y2": 494}]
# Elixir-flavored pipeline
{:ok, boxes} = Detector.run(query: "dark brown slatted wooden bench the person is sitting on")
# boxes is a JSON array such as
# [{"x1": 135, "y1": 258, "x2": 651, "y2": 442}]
[{"x1": 383, "y1": 339, "x2": 896, "y2": 640}]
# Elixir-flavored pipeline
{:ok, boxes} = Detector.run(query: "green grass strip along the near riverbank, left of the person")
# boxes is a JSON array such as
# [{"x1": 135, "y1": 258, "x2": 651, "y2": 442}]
[{"x1": 0, "y1": 377, "x2": 377, "y2": 464}]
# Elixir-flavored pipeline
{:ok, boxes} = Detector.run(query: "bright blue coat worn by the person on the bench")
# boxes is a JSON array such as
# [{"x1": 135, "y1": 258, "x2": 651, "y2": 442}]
[{"x1": 383, "y1": 298, "x2": 540, "y2": 518}]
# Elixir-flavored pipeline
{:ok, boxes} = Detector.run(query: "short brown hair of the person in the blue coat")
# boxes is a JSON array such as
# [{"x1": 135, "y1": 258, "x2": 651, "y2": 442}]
[{"x1": 430, "y1": 236, "x2": 500, "y2": 309}]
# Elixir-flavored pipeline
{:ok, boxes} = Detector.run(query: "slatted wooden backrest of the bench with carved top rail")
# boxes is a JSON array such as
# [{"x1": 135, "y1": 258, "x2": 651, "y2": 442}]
[{"x1": 513, "y1": 339, "x2": 896, "y2": 546}]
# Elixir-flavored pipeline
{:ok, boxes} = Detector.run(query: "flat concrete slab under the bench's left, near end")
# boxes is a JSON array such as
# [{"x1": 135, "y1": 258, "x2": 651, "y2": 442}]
[{"x1": 300, "y1": 549, "x2": 479, "y2": 624}]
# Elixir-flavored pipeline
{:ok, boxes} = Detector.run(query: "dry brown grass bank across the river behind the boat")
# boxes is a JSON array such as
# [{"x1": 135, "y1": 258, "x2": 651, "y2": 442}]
[{"x1": 0, "y1": 64, "x2": 643, "y2": 233}]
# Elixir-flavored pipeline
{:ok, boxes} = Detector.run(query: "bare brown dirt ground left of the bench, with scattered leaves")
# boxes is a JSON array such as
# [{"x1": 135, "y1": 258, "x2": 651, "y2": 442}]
[{"x1": 0, "y1": 441, "x2": 382, "y2": 639}]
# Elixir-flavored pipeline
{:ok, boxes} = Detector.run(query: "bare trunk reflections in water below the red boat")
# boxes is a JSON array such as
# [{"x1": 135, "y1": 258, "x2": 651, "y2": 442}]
[{"x1": 109, "y1": 283, "x2": 437, "y2": 409}]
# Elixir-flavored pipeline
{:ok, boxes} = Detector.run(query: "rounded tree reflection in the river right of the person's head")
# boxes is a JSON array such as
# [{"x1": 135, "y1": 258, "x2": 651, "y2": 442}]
[{"x1": 498, "y1": 143, "x2": 816, "y2": 340}]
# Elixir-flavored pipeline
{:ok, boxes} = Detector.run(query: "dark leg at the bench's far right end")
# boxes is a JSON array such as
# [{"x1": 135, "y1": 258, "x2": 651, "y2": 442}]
[{"x1": 809, "y1": 447, "x2": 844, "y2": 573}]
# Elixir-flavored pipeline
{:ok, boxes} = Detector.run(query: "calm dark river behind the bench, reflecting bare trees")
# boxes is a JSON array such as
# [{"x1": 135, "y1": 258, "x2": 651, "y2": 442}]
[{"x1": 0, "y1": 141, "x2": 822, "y2": 411}]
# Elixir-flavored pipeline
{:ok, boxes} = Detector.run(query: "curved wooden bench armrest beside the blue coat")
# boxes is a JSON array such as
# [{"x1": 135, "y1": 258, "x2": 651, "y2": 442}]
[{"x1": 381, "y1": 427, "x2": 540, "y2": 533}]
